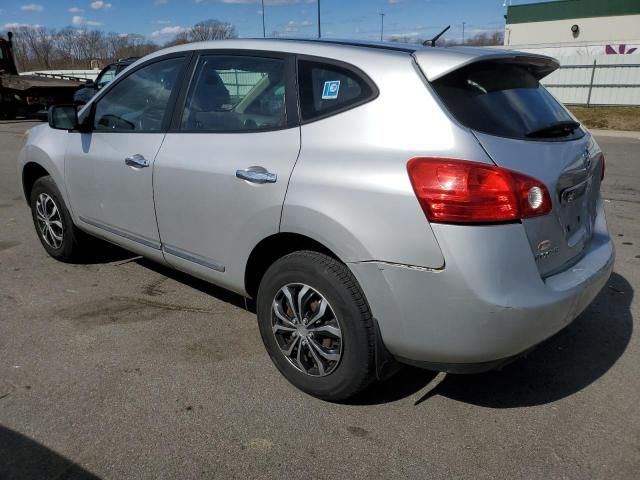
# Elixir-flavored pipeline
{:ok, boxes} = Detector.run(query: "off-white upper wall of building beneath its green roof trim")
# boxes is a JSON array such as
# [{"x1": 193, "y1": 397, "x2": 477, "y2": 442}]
[{"x1": 504, "y1": 14, "x2": 640, "y2": 46}]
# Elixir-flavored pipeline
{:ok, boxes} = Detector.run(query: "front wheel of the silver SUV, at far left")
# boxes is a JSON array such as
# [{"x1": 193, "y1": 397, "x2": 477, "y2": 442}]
[{"x1": 30, "y1": 175, "x2": 82, "y2": 262}]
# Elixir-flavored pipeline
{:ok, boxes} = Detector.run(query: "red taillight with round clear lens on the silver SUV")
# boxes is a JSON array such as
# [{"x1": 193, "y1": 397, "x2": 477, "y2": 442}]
[{"x1": 407, "y1": 158, "x2": 551, "y2": 223}]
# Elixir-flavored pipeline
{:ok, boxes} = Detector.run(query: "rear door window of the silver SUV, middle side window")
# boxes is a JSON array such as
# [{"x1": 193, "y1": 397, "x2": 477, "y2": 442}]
[{"x1": 181, "y1": 55, "x2": 287, "y2": 132}]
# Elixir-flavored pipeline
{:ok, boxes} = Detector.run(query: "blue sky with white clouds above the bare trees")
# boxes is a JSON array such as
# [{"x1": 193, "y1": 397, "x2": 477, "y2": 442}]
[{"x1": 0, "y1": 0, "x2": 535, "y2": 43}]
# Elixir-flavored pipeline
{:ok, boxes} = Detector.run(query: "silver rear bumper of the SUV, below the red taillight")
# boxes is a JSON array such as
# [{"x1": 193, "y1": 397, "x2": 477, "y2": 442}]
[{"x1": 349, "y1": 214, "x2": 615, "y2": 364}]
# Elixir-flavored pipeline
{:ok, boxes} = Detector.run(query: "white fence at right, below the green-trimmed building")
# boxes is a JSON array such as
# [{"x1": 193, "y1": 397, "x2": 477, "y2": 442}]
[{"x1": 542, "y1": 55, "x2": 640, "y2": 106}]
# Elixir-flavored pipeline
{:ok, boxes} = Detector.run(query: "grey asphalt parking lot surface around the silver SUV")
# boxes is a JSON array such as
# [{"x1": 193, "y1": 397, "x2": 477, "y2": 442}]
[{"x1": 0, "y1": 121, "x2": 640, "y2": 479}]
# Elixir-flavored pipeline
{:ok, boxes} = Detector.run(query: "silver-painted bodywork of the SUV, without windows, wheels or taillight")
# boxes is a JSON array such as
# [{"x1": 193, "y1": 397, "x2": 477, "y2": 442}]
[{"x1": 18, "y1": 40, "x2": 615, "y2": 370}]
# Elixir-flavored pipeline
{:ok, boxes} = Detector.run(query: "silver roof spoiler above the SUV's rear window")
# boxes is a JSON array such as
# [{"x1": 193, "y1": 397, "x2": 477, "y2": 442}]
[{"x1": 413, "y1": 47, "x2": 560, "y2": 82}]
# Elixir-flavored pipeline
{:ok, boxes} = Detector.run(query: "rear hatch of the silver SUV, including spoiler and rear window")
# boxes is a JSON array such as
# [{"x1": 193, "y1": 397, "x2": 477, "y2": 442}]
[{"x1": 415, "y1": 49, "x2": 604, "y2": 276}]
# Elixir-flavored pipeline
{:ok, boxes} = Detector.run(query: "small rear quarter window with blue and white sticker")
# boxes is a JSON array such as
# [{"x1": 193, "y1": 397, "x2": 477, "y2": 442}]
[{"x1": 298, "y1": 60, "x2": 377, "y2": 122}]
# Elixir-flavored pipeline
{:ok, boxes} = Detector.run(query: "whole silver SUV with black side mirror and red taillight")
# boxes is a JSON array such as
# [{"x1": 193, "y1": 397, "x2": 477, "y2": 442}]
[{"x1": 19, "y1": 40, "x2": 614, "y2": 400}]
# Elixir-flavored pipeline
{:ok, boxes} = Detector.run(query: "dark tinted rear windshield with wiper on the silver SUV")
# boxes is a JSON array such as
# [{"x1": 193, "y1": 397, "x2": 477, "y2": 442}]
[{"x1": 432, "y1": 62, "x2": 583, "y2": 140}]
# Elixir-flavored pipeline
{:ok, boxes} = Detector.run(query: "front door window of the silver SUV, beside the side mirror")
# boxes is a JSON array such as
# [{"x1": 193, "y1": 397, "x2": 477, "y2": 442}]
[{"x1": 93, "y1": 57, "x2": 184, "y2": 132}]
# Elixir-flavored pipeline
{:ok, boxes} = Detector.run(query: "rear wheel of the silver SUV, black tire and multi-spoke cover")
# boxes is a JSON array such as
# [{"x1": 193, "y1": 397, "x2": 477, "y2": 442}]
[{"x1": 257, "y1": 251, "x2": 375, "y2": 401}]
